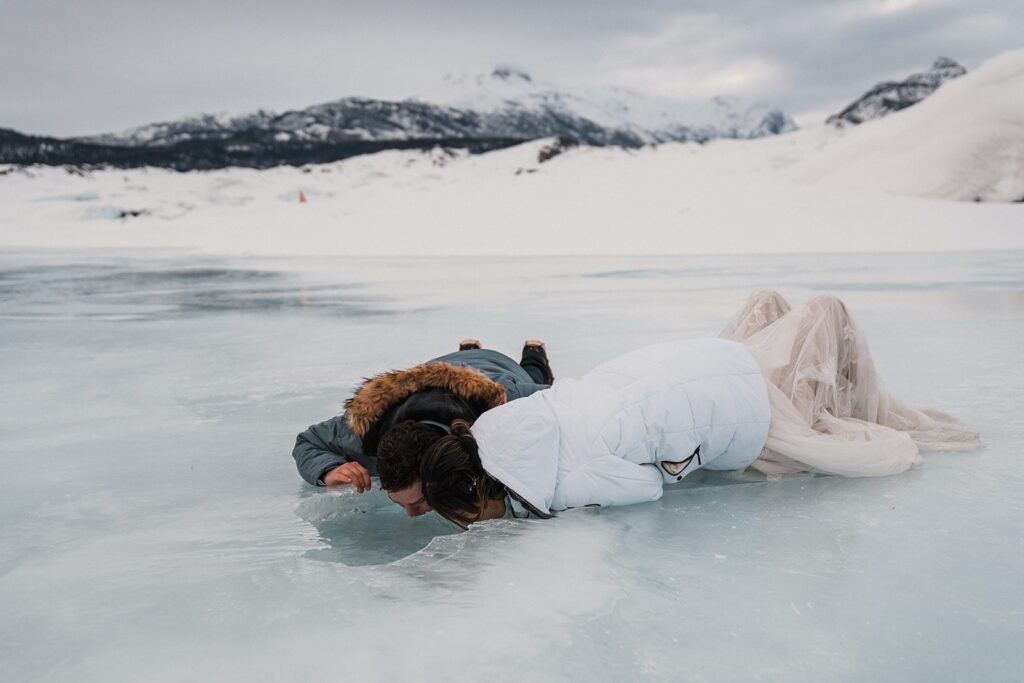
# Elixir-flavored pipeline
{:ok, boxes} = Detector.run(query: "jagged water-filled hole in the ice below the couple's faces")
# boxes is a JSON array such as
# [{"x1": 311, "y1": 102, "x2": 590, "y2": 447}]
[{"x1": 295, "y1": 489, "x2": 458, "y2": 566}]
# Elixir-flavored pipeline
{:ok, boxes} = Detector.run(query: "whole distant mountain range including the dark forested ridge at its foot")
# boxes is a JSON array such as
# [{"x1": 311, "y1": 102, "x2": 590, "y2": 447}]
[{"x1": 0, "y1": 69, "x2": 796, "y2": 171}]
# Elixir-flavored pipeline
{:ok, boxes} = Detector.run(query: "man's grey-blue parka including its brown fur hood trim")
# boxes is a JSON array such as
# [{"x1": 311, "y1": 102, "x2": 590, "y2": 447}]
[{"x1": 292, "y1": 349, "x2": 548, "y2": 485}]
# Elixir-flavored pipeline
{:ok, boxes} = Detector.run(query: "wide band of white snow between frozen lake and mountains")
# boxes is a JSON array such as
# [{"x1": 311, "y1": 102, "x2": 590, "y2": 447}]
[{"x1": 0, "y1": 50, "x2": 1024, "y2": 255}]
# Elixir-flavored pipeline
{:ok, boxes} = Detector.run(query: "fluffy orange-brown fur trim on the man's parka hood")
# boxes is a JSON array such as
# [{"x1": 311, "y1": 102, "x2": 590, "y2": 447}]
[{"x1": 345, "y1": 362, "x2": 507, "y2": 438}]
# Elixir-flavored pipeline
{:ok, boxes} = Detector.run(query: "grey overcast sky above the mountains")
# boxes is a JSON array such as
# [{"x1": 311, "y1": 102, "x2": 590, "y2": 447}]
[{"x1": 0, "y1": 0, "x2": 1024, "y2": 136}]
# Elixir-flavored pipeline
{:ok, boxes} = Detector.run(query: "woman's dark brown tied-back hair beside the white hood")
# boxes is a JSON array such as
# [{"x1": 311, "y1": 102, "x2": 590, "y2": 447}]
[{"x1": 420, "y1": 420, "x2": 505, "y2": 526}]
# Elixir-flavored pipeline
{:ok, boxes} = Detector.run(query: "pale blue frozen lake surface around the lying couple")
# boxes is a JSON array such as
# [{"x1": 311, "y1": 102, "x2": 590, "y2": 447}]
[{"x1": 0, "y1": 251, "x2": 1024, "y2": 681}]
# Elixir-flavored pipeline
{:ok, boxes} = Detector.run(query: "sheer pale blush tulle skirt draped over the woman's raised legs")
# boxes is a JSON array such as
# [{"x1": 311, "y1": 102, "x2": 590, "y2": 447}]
[{"x1": 720, "y1": 290, "x2": 981, "y2": 476}]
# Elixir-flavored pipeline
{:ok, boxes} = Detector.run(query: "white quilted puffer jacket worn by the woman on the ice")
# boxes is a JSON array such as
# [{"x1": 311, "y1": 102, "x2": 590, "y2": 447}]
[{"x1": 473, "y1": 339, "x2": 771, "y2": 513}]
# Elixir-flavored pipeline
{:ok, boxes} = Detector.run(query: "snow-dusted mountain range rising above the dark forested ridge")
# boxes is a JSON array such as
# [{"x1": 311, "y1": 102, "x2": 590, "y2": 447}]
[{"x1": 82, "y1": 69, "x2": 796, "y2": 152}]
